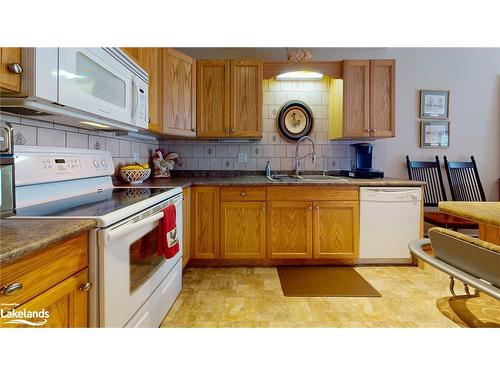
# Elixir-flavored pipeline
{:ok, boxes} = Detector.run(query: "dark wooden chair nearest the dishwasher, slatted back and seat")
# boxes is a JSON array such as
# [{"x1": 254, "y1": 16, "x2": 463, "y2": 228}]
[{"x1": 406, "y1": 155, "x2": 479, "y2": 230}]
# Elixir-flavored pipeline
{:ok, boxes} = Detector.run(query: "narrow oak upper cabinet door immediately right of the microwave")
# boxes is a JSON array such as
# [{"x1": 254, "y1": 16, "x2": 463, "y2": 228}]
[{"x1": 139, "y1": 48, "x2": 164, "y2": 133}]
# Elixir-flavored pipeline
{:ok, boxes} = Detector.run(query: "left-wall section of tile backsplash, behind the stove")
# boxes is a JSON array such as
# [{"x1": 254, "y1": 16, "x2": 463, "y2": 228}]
[{"x1": 0, "y1": 112, "x2": 159, "y2": 175}]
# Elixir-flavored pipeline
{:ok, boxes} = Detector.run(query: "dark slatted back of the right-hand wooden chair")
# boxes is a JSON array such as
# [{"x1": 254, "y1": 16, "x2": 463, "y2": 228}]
[{"x1": 444, "y1": 156, "x2": 486, "y2": 202}]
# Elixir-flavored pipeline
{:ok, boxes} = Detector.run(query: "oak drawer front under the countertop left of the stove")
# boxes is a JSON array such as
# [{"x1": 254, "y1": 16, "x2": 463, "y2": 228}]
[{"x1": 0, "y1": 232, "x2": 88, "y2": 309}]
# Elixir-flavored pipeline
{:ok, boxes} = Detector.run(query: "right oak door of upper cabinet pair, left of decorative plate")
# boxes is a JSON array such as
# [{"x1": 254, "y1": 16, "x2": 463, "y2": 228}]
[{"x1": 230, "y1": 60, "x2": 262, "y2": 137}]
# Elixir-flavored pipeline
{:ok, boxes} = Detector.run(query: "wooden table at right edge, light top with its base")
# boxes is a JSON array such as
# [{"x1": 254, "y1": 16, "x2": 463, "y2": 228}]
[{"x1": 438, "y1": 201, "x2": 500, "y2": 245}]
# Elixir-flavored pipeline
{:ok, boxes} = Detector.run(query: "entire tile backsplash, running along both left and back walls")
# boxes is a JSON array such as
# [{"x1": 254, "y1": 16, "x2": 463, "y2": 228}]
[{"x1": 0, "y1": 78, "x2": 351, "y2": 176}]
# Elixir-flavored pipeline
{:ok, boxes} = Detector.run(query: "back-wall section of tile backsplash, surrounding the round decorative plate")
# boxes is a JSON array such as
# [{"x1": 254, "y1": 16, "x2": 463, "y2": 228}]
[{"x1": 161, "y1": 78, "x2": 351, "y2": 171}]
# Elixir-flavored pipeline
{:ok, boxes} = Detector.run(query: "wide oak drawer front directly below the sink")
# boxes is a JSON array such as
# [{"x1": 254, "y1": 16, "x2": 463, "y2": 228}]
[{"x1": 267, "y1": 185, "x2": 358, "y2": 202}]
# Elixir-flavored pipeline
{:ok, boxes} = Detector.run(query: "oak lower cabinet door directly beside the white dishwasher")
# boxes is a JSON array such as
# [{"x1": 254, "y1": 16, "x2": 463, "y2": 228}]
[{"x1": 313, "y1": 202, "x2": 359, "y2": 258}]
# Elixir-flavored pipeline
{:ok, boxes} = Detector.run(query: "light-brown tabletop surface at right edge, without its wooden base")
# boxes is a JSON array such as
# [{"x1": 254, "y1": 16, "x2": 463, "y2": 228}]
[{"x1": 439, "y1": 202, "x2": 500, "y2": 227}]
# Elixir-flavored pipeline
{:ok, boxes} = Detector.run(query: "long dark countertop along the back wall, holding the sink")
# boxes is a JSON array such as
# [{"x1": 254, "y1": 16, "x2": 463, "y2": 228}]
[{"x1": 115, "y1": 175, "x2": 425, "y2": 188}]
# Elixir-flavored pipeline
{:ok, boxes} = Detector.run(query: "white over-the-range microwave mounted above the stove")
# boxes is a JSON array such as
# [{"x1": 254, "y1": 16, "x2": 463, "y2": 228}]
[{"x1": 0, "y1": 48, "x2": 149, "y2": 131}]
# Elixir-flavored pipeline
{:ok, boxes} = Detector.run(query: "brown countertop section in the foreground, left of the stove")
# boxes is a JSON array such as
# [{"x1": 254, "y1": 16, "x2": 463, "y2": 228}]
[{"x1": 0, "y1": 219, "x2": 95, "y2": 266}]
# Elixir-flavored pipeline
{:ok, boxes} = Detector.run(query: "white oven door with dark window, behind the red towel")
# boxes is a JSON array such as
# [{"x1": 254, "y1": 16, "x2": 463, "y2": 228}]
[{"x1": 99, "y1": 195, "x2": 182, "y2": 327}]
